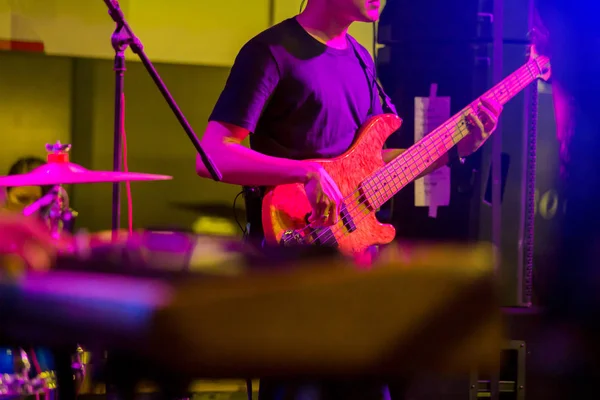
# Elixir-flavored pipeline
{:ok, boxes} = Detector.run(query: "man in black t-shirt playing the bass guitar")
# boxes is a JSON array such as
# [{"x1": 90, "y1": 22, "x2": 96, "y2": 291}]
[{"x1": 196, "y1": 0, "x2": 502, "y2": 400}]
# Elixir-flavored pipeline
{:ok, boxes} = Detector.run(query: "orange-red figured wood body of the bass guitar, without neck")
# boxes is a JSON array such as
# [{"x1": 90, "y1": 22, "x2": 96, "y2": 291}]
[{"x1": 262, "y1": 114, "x2": 402, "y2": 255}]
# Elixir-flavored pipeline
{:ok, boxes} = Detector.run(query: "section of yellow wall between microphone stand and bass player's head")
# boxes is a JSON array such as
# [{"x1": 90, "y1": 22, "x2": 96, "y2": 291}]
[{"x1": 129, "y1": 0, "x2": 270, "y2": 66}]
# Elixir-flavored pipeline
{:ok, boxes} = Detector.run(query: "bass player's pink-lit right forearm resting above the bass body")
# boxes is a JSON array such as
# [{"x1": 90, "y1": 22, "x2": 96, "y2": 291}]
[{"x1": 196, "y1": 143, "x2": 315, "y2": 186}]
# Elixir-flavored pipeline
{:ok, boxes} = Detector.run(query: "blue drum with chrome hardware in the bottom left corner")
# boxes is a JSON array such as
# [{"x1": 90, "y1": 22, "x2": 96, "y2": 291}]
[{"x1": 0, "y1": 347, "x2": 56, "y2": 398}]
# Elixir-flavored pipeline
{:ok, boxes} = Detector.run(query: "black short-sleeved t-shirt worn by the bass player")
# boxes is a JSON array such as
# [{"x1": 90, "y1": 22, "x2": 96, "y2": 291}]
[{"x1": 209, "y1": 18, "x2": 383, "y2": 160}]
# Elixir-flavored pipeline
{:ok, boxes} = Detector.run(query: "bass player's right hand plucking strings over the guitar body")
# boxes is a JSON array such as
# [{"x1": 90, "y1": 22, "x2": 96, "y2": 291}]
[{"x1": 304, "y1": 163, "x2": 343, "y2": 226}]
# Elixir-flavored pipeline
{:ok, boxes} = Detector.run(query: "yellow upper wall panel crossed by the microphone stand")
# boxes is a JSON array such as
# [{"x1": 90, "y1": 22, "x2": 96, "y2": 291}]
[{"x1": 0, "y1": 0, "x2": 270, "y2": 66}]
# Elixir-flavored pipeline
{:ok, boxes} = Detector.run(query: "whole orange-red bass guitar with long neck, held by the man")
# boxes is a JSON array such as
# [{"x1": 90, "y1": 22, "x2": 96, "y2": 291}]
[{"x1": 262, "y1": 46, "x2": 551, "y2": 255}]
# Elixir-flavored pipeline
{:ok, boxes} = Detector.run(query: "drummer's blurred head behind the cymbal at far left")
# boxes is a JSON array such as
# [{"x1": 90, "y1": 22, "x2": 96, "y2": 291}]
[{"x1": 0, "y1": 156, "x2": 46, "y2": 213}]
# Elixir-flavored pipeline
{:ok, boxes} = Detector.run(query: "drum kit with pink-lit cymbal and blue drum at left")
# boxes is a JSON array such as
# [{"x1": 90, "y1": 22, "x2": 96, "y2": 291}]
[{"x1": 0, "y1": 142, "x2": 172, "y2": 398}]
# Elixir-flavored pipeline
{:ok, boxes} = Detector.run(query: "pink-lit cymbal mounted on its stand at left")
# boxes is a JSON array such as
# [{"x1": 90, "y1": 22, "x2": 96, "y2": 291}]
[{"x1": 0, "y1": 162, "x2": 173, "y2": 187}]
